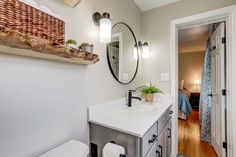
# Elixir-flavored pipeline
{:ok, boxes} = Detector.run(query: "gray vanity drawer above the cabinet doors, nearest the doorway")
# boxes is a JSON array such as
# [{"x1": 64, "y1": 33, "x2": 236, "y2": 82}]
[{"x1": 157, "y1": 107, "x2": 172, "y2": 135}]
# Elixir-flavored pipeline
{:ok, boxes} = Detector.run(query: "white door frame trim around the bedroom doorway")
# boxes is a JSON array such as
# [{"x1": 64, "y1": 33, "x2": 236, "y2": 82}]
[{"x1": 171, "y1": 5, "x2": 236, "y2": 157}]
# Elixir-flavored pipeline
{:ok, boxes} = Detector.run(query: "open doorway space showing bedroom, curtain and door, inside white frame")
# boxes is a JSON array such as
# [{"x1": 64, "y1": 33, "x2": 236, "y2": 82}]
[{"x1": 178, "y1": 22, "x2": 226, "y2": 157}]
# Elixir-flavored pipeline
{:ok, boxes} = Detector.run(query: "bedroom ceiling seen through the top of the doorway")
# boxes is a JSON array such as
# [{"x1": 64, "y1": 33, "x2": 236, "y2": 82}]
[{"x1": 179, "y1": 25, "x2": 209, "y2": 53}]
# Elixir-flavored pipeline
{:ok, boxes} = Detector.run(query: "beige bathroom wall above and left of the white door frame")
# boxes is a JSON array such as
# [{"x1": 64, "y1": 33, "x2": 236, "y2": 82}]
[{"x1": 142, "y1": 0, "x2": 236, "y2": 93}]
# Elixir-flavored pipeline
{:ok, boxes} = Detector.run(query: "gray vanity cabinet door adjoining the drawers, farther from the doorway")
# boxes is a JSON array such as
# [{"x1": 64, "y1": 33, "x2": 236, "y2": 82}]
[{"x1": 157, "y1": 126, "x2": 167, "y2": 157}]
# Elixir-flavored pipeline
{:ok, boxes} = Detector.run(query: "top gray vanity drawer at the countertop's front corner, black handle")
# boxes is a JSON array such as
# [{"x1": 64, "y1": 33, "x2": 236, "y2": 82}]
[{"x1": 141, "y1": 123, "x2": 157, "y2": 156}]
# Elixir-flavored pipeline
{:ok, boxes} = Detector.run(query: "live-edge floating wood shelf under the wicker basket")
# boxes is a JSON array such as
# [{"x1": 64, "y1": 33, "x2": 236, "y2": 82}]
[{"x1": 0, "y1": 31, "x2": 99, "y2": 65}]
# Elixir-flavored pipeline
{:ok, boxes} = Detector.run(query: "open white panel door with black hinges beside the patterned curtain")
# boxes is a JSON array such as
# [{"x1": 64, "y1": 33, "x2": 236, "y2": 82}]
[{"x1": 211, "y1": 22, "x2": 226, "y2": 157}]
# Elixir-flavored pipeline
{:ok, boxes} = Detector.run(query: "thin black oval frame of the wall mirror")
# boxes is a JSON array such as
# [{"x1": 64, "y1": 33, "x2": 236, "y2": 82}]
[{"x1": 106, "y1": 22, "x2": 139, "y2": 85}]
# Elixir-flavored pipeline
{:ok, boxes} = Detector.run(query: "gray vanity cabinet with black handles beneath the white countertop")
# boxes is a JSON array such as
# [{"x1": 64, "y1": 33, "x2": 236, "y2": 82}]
[{"x1": 90, "y1": 105, "x2": 172, "y2": 157}]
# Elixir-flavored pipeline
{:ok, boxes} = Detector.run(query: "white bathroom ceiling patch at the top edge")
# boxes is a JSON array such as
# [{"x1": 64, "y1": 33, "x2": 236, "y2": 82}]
[{"x1": 134, "y1": 0, "x2": 180, "y2": 11}]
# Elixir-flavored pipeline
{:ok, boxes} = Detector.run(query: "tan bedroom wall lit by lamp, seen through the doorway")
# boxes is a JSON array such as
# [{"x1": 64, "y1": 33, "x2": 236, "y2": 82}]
[{"x1": 179, "y1": 52, "x2": 205, "y2": 92}]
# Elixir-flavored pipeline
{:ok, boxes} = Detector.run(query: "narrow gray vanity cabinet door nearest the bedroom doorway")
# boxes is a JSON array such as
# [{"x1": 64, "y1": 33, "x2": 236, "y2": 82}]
[{"x1": 165, "y1": 119, "x2": 172, "y2": 157}]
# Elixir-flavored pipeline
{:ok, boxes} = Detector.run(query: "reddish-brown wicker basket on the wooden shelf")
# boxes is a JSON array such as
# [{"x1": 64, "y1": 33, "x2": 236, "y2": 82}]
[{"x1": 0, "y1": 0, "x2": 65, "y2": 44}]
